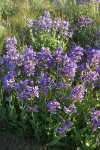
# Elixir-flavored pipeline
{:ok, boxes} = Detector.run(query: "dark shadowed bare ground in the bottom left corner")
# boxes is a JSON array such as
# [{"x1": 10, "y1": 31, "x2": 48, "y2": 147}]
[{"x1": 0, "y1": 131, "x2": 61, "y2": 150}]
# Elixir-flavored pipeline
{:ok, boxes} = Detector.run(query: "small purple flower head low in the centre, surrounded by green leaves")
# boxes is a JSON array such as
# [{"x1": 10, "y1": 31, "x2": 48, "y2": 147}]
[{"x1": 47, "y1": 99, "x2": 61, "y2": 114}]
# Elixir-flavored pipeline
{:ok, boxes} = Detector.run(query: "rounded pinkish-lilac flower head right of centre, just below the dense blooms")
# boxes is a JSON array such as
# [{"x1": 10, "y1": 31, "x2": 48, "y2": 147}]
[{"x1": 70, "y1": 84, "x2": 86, "y2": 100}]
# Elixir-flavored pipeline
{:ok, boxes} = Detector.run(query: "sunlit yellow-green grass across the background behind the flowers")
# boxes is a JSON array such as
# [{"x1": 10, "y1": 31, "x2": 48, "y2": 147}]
[{"x1": 0, "y1": 0, "x2": 100, "y2": 48}]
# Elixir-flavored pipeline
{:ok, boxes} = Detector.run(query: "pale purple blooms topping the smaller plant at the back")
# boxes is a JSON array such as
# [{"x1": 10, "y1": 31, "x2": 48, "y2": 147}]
[{"x1": 26, "y1": 11, "x2": 73, "y2": 37}]
